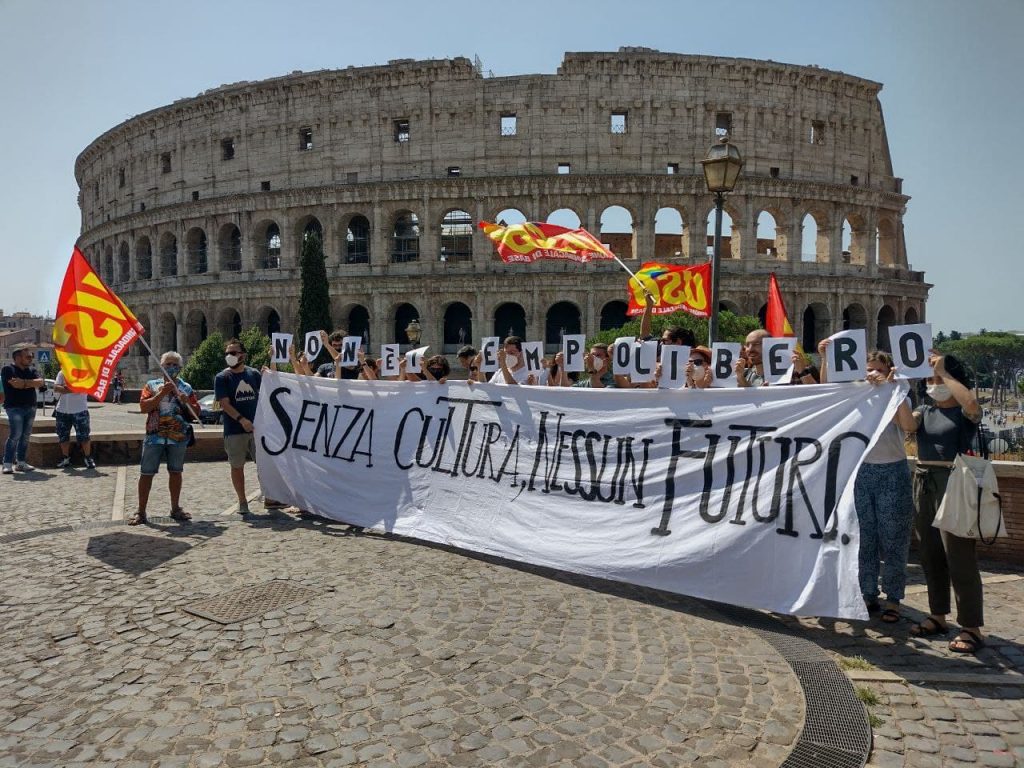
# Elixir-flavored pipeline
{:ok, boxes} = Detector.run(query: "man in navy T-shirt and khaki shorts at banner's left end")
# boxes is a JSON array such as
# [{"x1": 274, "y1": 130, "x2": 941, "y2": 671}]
[{"x1": 213, "y1": 339, "x2": 271, "y2": 515}]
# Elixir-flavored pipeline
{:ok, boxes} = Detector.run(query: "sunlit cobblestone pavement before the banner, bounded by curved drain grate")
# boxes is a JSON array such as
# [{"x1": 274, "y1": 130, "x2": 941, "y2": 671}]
[{"x1": 0, "y1": 463, "x2": 798, "y2": 767}]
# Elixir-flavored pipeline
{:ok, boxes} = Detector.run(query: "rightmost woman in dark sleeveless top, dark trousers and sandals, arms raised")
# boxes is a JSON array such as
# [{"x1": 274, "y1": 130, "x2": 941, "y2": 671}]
[{"x1": 909, "y1": 349, "x2": 985, "y2": 653}]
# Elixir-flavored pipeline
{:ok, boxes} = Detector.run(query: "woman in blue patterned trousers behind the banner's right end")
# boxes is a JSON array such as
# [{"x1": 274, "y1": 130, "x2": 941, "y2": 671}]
[{"x1": 818, "y1": 346, "x2": 916, "y2": 624}]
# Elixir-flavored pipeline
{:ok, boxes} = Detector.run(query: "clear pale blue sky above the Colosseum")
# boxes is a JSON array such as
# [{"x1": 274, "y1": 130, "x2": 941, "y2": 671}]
[{"x1": 0, "y1": 0, "x2": 1024, "y2": 331}]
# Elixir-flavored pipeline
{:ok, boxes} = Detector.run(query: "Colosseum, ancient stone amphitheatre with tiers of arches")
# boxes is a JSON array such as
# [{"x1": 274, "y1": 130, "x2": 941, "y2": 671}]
[{"x1": 75, "y1": 48, "x2": 930, "y2": 374}]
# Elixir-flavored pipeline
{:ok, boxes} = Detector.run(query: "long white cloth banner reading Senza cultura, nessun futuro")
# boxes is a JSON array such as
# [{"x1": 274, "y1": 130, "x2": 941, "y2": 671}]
[{"x1": 256, "y1": 373, "x2": 907, "y2": 618}]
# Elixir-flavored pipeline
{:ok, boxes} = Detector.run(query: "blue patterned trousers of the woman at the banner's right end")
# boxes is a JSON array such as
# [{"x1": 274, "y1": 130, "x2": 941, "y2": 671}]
[{"x1": 853, "y1": 461, "x2": 913, "y2": 602}]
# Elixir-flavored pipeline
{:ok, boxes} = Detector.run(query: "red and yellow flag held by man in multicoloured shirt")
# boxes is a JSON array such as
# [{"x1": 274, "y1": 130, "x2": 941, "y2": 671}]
[{"x1": 53, "y1": 247, "x2": 145, "y2": 400}]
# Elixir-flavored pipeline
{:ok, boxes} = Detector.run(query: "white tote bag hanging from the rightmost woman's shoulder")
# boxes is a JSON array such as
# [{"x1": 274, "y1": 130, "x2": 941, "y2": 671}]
[{"x1": 932, "y1": 454, "x2": 1008, "y2": 544}]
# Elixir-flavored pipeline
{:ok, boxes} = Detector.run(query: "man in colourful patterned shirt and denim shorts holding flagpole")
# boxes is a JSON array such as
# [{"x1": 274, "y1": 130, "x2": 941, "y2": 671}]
[{"x1": 128, "y1": 352, "x2": 199, "y2": 525}]
